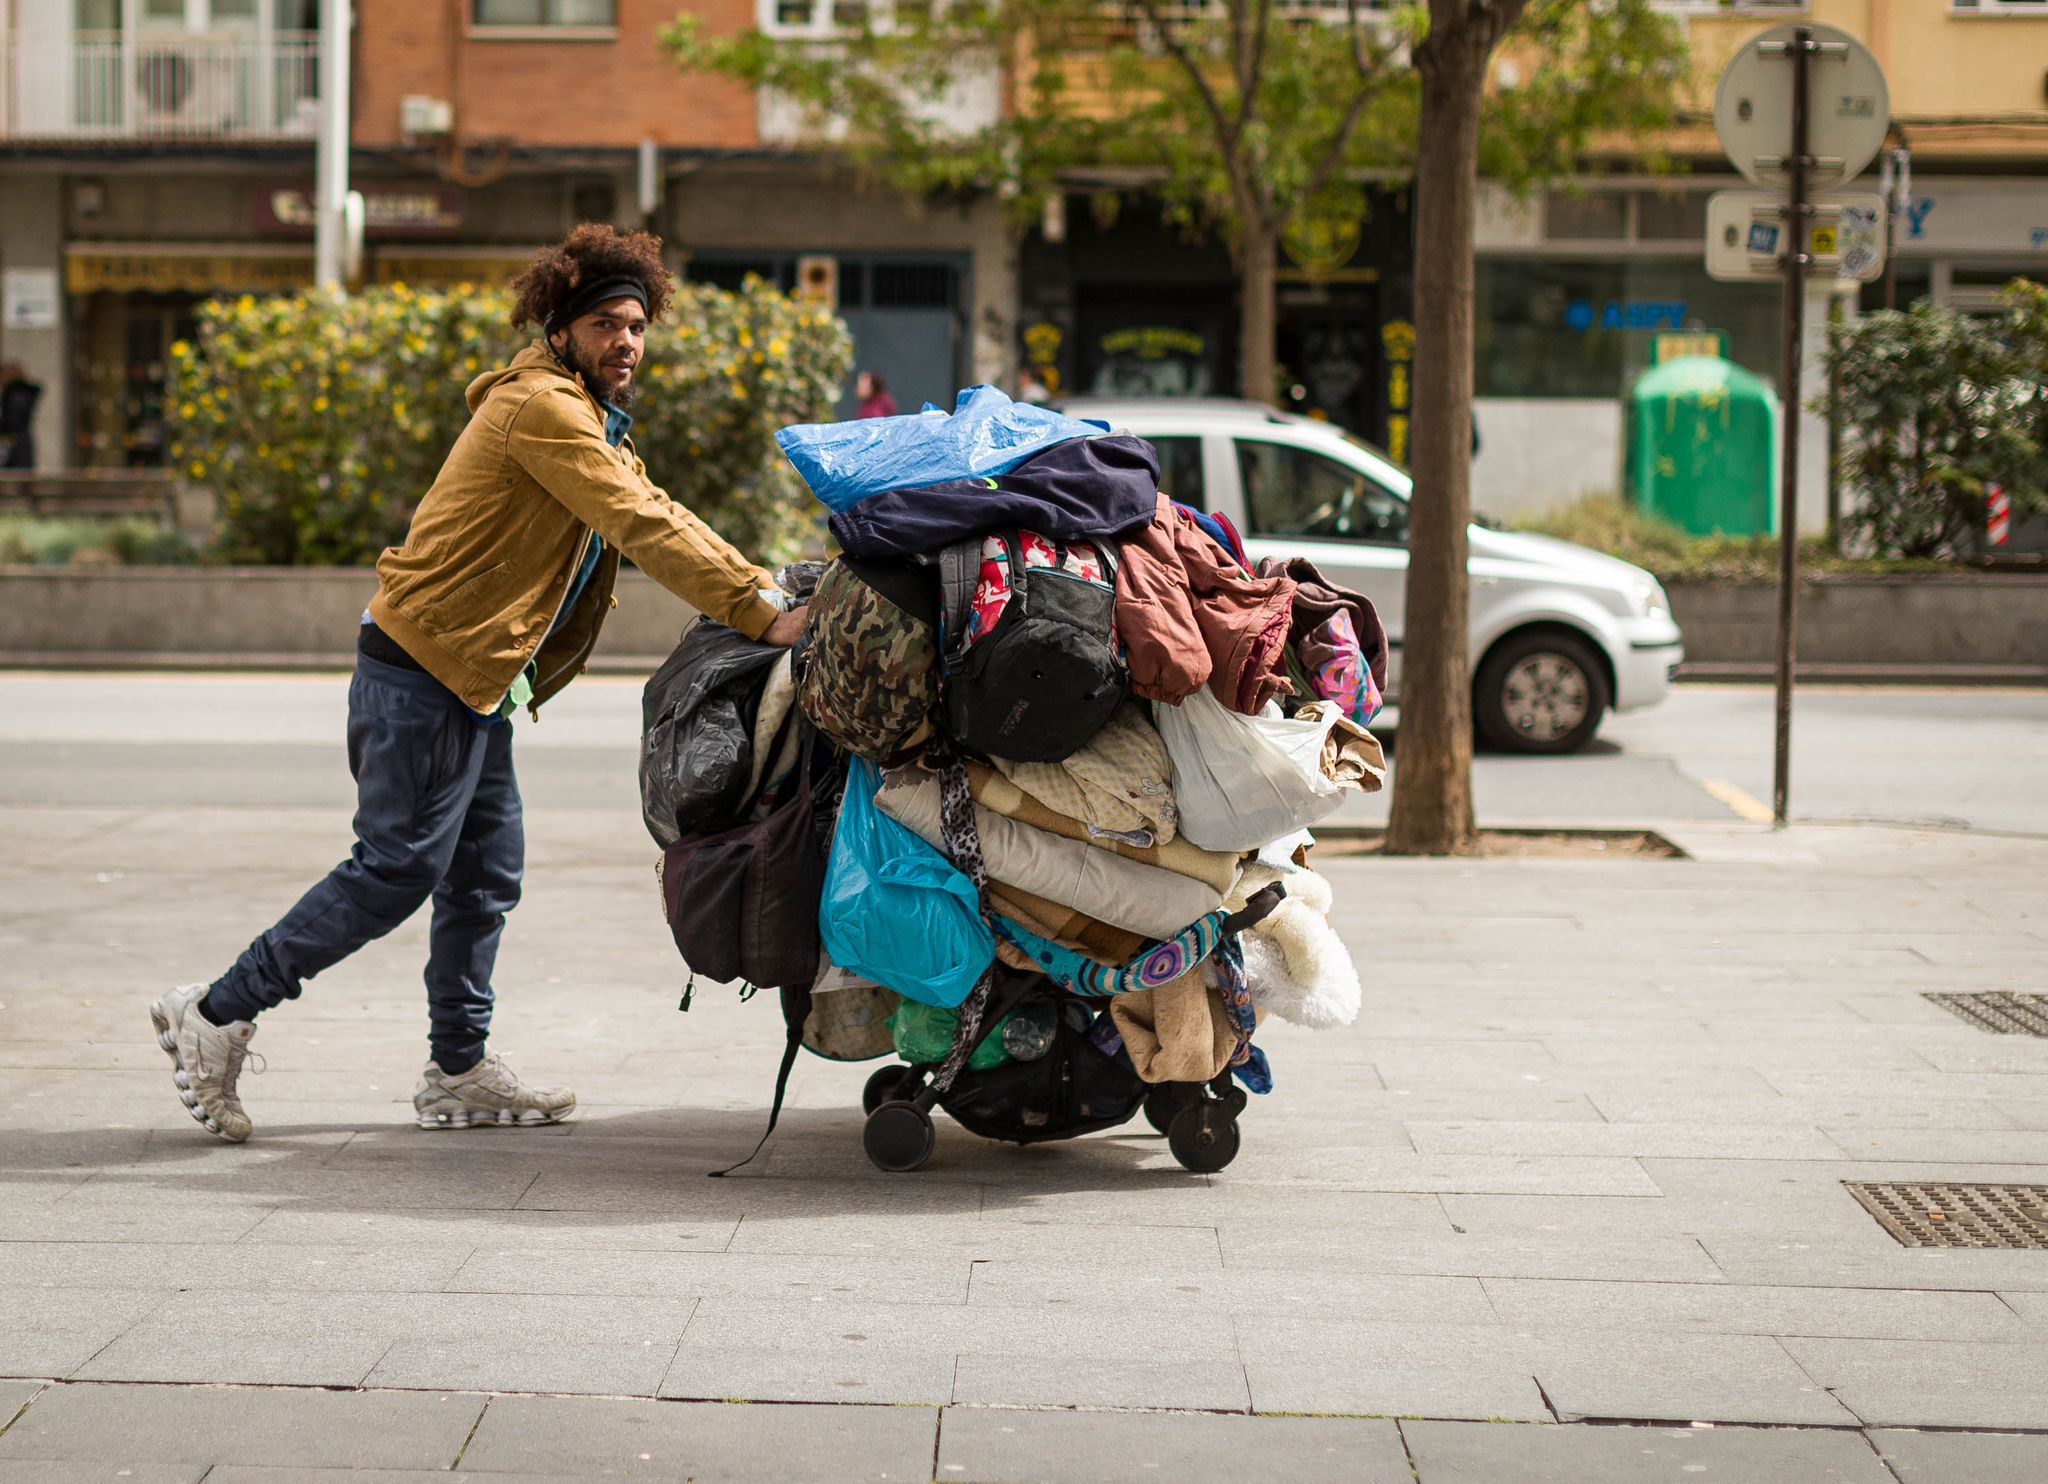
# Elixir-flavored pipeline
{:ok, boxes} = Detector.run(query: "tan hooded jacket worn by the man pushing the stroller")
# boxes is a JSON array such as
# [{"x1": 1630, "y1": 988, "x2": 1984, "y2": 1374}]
[{"x1": 371, "y1": 340, "x2": 776, "y2": 710}]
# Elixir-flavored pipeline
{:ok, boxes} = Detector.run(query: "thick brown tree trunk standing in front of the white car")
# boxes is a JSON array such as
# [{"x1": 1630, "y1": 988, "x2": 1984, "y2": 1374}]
[{"x1": 1386, "y1": 23, "x2": 1493, "y2": 856}]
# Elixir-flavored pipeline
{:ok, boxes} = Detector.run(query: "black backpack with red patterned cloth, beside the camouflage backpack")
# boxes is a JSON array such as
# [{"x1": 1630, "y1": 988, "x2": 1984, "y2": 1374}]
[{"x1": 938, "y1": 530, "x2": 1130, "y2": 763}]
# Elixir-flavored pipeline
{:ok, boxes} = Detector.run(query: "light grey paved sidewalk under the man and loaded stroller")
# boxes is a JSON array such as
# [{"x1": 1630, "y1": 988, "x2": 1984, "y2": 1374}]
[{"x1": 0, "y1": 786, "x2": 2048, "y2": 1484}]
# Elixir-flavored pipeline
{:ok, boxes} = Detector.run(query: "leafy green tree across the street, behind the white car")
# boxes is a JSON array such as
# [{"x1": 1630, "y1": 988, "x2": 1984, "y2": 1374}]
[{"x1": 664, "y1": 0, "x2": 1683, "y2": 397}]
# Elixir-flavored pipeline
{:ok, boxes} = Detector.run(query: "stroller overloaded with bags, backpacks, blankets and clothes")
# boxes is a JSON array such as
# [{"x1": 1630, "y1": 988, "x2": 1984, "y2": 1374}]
[{"x1": 641, "y1": 387, "x2": 1386, "y2": 1171}]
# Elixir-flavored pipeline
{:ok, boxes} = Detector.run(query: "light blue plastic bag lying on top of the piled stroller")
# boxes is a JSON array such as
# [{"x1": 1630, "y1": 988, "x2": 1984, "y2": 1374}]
[{"x1": 774, "y1": 387, "x2": 1110, "y2": 512}]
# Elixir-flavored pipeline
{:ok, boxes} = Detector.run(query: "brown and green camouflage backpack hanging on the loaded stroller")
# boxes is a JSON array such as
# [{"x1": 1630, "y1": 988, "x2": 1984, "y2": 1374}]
[{"x1": 797, "y1": 557, "x2": 938, "y2": 761}]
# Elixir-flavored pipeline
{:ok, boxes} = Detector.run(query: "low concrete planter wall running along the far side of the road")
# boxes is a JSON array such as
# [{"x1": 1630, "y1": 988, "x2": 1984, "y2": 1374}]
[{"x1": 0, "y1": 567, "x2": 2048, "y2": 678}]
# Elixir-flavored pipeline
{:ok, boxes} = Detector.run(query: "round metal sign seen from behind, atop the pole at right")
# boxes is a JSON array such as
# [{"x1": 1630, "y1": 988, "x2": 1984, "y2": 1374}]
[{"x1": 1714, "y1": 25, "x2": 1892, "y2": 190}]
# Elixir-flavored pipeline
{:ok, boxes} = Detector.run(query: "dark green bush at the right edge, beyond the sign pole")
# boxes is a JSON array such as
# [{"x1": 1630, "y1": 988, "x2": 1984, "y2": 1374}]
[{"x1": 1829, "y1": 280, "x2": 2048, "y2": 557}]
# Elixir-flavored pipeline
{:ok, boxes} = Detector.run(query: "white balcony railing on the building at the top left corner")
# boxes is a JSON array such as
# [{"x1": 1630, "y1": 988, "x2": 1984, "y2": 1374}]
[{"x1": 0, "y1": 31, "x2": 319, "y2": 143}]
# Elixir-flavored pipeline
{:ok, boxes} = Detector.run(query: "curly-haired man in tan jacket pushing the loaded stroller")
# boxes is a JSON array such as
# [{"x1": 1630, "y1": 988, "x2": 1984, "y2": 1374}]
[{"x1": 150, "y1": 225, "x2": 805, "y2": 1140}]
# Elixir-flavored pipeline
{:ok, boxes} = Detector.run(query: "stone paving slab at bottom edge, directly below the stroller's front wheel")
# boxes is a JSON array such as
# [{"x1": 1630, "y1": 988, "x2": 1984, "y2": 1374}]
[{"x1": 938, "y1": 1406, "x2": 1411, "y2": 1484}]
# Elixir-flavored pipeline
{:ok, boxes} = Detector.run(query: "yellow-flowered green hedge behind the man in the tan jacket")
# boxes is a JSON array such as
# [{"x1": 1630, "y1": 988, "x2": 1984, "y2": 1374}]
[{"x1": 170, "y1": 282, "x2": 852, "y2": 567}]
